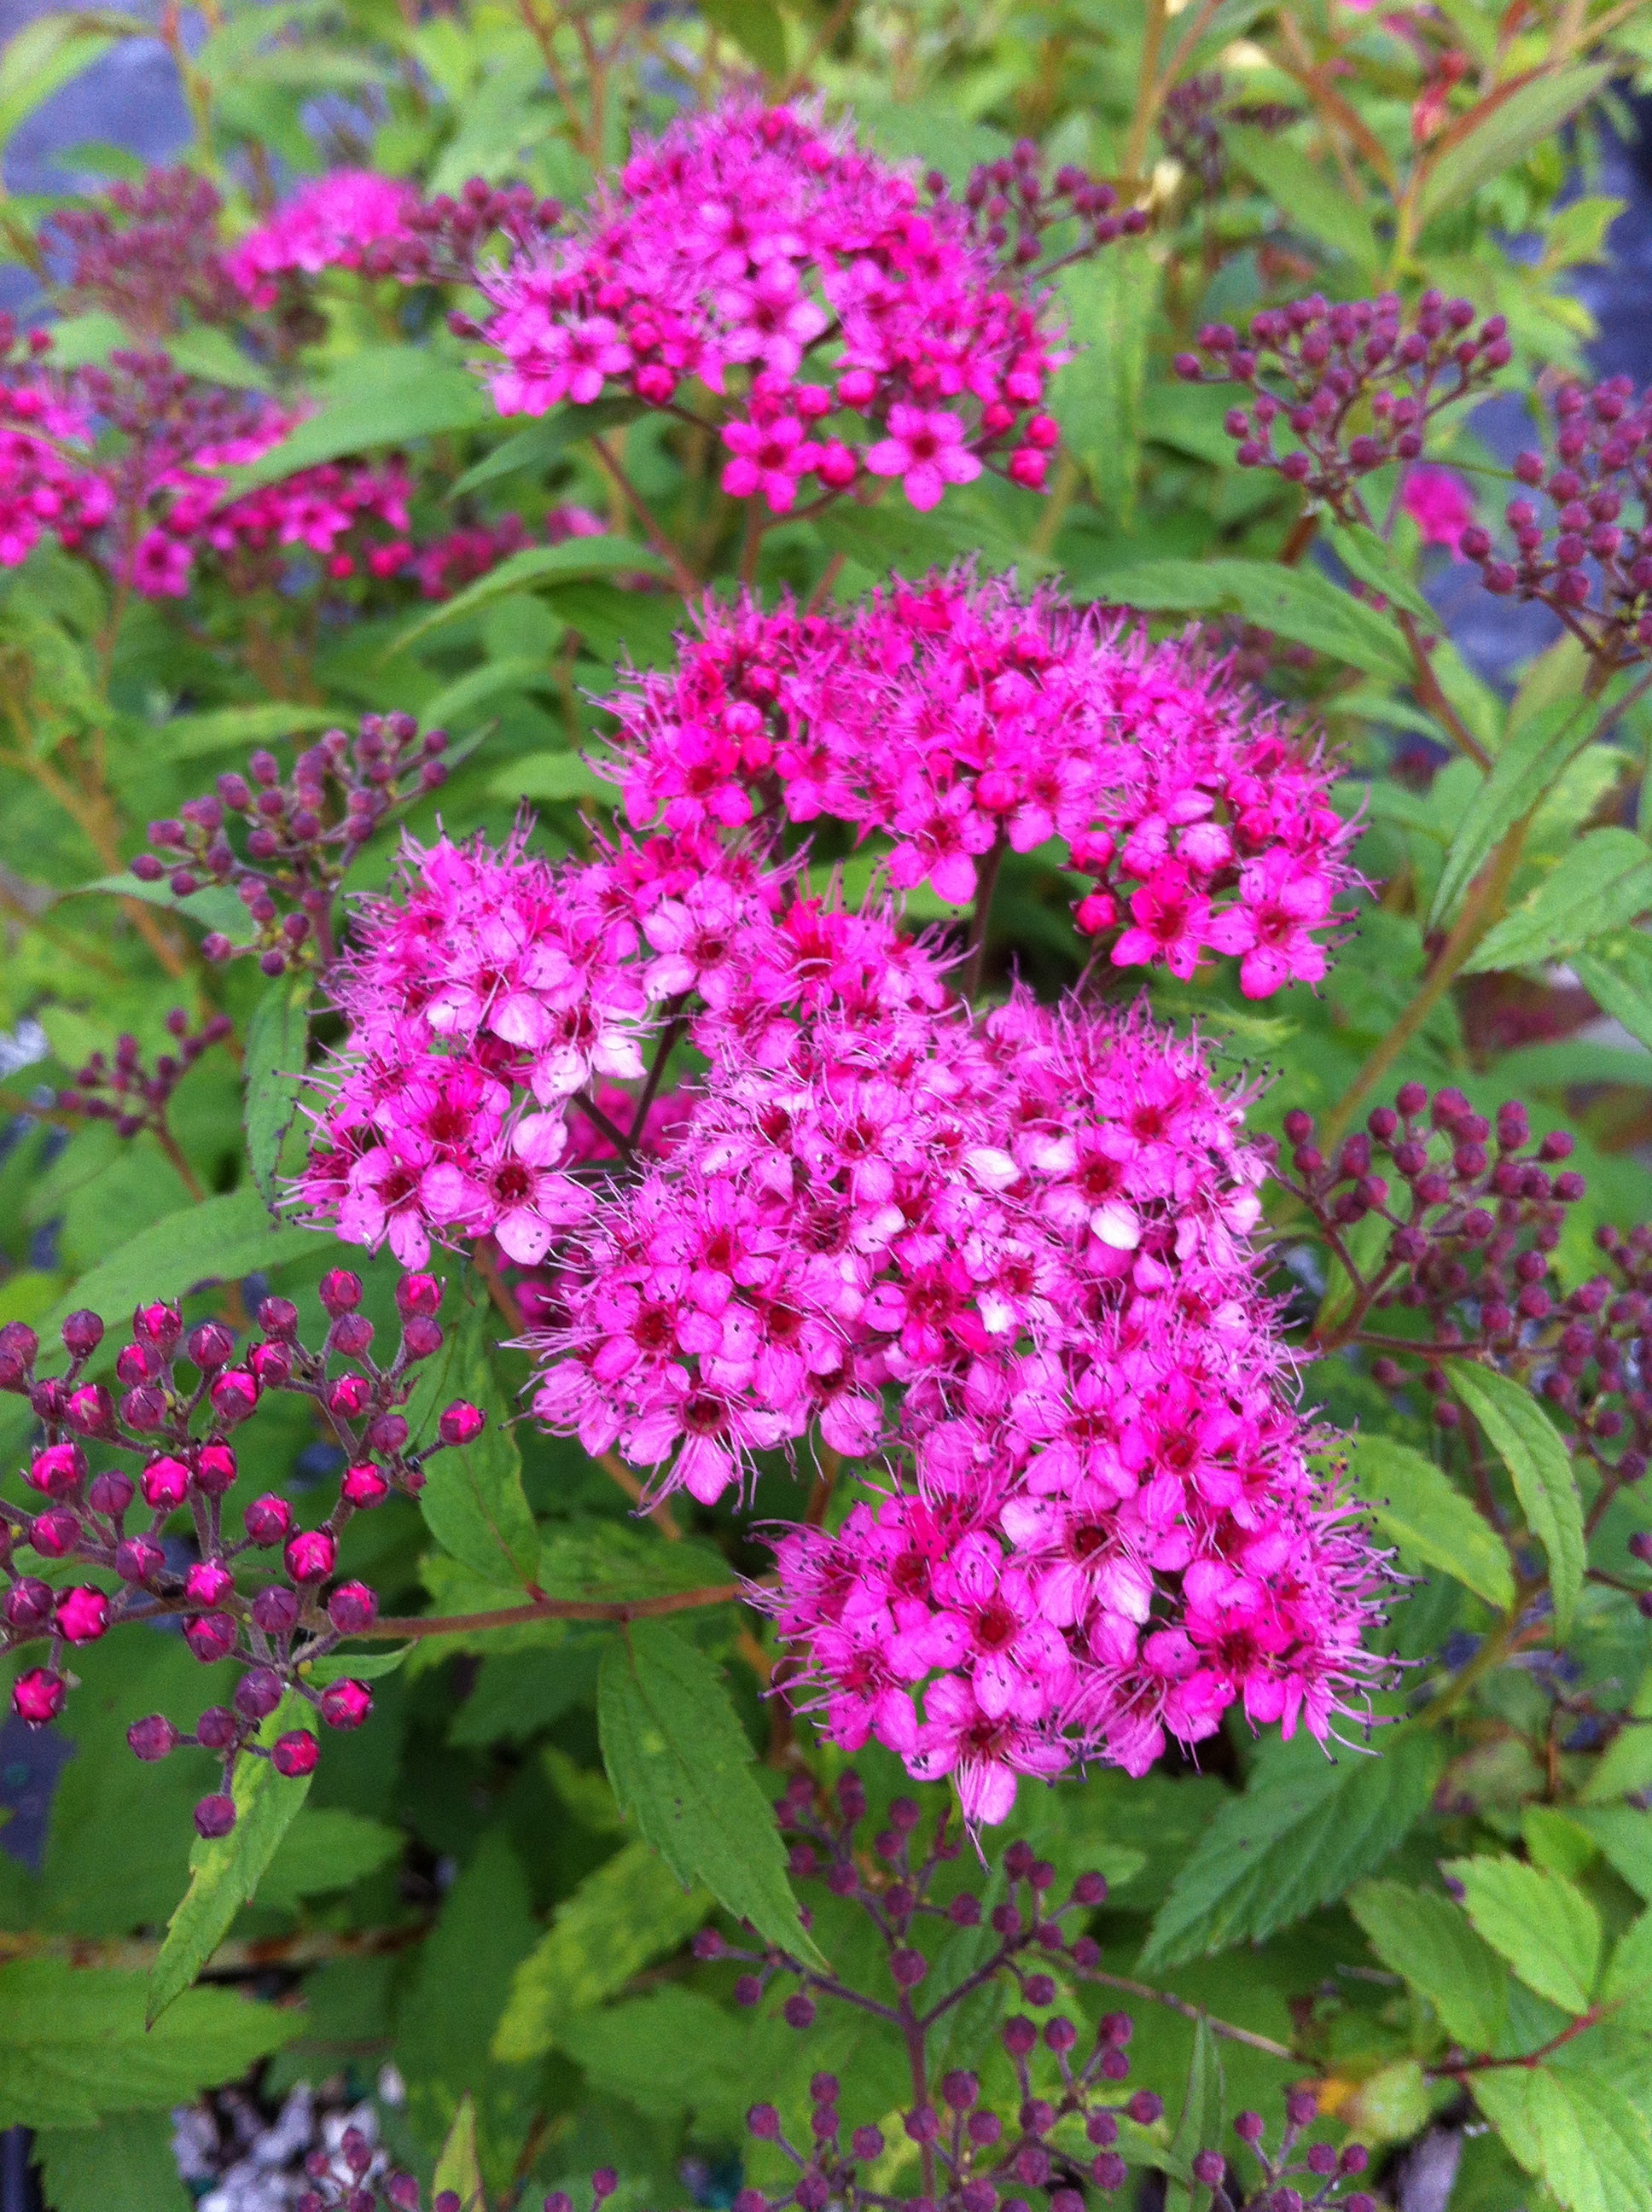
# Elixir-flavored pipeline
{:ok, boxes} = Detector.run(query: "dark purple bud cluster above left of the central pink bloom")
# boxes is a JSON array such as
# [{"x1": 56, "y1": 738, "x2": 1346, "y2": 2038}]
[{"x1": 133, "y1": 714, "x2": 447, "y2": 975}]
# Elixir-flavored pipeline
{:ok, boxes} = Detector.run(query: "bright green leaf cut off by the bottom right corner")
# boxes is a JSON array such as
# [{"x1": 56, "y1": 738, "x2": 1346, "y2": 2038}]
[{"x1": 1473, "y1": 2066, "x2": 1652, "y2": 2212}]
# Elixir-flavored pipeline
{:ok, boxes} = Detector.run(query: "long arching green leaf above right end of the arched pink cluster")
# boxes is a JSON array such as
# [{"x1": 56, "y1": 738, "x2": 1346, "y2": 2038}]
[{"x1": 1084, "y1": 560, "x2": 1411, "y2": 684}]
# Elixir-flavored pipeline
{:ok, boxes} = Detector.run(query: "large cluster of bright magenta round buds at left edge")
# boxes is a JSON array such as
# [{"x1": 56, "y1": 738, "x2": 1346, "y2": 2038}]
[{"x1": 0, "y1": 1267, "x2": 485, "y2": 1836}]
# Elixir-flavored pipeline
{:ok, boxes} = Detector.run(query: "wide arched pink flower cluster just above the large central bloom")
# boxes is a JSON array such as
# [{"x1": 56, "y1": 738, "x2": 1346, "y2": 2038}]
[{"x1": 608, "y1": 573, "x2": 1353, "y2": 998}]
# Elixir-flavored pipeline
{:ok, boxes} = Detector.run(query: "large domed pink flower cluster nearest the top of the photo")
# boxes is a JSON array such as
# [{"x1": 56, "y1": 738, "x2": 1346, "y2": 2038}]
[{"x1": 480, "y1": 102, "x2": 1119, "y2": 513}]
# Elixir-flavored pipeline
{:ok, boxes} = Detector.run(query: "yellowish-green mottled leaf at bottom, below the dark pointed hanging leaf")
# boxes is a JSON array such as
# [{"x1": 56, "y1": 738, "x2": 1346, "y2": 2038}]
[{"x1": 493, "y1": 1841, "x2": 713, "y2": 2064}]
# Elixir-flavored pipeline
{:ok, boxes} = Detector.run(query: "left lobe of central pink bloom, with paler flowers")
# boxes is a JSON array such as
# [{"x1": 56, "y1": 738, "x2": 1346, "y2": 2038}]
[{"x1": 296, "y1": 836, "x2": 827, "y2": 1267}]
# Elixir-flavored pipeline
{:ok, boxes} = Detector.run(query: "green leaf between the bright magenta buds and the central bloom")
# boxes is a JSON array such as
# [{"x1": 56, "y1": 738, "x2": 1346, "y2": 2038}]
[{"x1": 407, "y1": 1305, "x2": 539, "y2": 1591}]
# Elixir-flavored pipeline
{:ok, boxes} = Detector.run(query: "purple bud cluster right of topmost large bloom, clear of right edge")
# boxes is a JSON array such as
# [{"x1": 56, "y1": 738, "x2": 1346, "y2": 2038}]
[{"x1": 1177, "y1": 292, "x2": 1513, "y2": 524}]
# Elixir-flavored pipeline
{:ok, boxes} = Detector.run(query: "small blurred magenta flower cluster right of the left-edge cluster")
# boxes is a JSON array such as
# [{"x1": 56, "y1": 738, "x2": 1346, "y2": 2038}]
[{"x1": 131, "y1": 405, "x2": 414, "y2": 599}]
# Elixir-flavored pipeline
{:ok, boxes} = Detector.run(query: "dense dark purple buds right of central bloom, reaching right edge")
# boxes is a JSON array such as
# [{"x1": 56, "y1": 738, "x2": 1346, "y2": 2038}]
[{"x1": 1274, "y1": 1084, "x2": 1652, "y2": 1488}]
